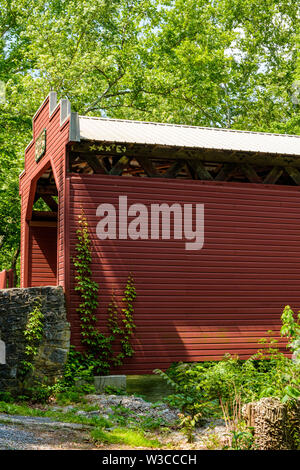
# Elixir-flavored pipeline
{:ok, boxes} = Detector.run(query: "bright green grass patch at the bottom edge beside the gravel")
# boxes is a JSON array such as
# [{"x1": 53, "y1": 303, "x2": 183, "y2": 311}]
[{"x1": 91, "y1": 428, "x2": 161, "y2": 448}]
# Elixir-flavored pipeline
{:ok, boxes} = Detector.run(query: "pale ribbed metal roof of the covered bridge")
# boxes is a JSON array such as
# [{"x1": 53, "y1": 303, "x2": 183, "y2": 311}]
[{"x1": 79, "y1": 116, "x2": 300, "y2": 155}]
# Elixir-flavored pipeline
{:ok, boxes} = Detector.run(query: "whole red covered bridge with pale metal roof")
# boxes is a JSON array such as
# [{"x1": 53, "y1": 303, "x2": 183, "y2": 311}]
[{"x1": 20, "y1": 92, "x2": 300, "y2": 373}]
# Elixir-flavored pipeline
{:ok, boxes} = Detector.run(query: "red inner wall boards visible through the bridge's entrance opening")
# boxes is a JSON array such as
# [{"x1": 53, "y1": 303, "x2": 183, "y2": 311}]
[{"x1": 29, "y1": 227, "x2": 57, "y2": 287}]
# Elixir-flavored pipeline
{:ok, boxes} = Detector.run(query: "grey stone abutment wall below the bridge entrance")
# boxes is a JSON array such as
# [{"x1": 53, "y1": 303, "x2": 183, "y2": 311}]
[{"x1": 0, "y1": 287, "x2": 70, "y2": 391}]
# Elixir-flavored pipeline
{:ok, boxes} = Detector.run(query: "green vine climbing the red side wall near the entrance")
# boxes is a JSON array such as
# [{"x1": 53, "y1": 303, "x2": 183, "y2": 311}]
[{"x1": 73, "y1": 209, "x2": 136, "y2": 374}]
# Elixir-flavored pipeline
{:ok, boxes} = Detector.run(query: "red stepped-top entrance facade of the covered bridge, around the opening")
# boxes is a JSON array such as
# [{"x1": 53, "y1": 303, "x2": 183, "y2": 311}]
[{"x1": 20, "y1": 98, "x2": 69, "y2": 287}]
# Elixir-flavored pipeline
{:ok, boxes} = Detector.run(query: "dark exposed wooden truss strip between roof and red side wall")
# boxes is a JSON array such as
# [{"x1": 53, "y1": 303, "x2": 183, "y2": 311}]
[{"x1": 69, "y1": 141, "x2": 300, "y2": 186}]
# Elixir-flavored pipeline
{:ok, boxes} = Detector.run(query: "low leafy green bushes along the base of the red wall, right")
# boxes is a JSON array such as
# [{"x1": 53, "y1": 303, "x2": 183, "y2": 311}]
[{"x1": 160, "y1": 354, "x2": 299, "y2": 415}]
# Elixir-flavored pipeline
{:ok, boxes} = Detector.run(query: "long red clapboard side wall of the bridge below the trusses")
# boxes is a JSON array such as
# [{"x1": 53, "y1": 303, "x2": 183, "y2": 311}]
[{"x1": 67, "y1": 175, "x2": 300, "y2": 373}]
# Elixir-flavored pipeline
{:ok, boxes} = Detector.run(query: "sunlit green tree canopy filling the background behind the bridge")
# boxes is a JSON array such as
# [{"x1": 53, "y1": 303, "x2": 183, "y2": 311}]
[{"x1": 0, "y1": 0, "x2": 300, "y2": 276}]
